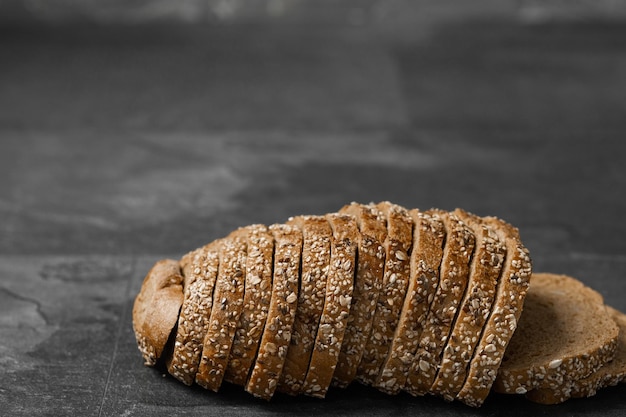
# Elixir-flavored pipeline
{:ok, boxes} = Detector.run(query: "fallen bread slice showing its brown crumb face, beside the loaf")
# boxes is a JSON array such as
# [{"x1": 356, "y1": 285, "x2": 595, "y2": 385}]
[{"x1": 494, "y1": 274, "x2": 619, "y2": 394}]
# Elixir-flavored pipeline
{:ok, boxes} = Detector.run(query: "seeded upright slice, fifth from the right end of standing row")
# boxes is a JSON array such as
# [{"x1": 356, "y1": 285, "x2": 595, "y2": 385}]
[{"x1": 357, "y1": 201, "x2": 413, "y2": 385}]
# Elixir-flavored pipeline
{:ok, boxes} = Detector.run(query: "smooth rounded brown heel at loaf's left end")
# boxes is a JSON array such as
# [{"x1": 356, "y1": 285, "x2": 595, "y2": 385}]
[{"x1": 133, "y1": 259, "x2": 183, "y2": 366}]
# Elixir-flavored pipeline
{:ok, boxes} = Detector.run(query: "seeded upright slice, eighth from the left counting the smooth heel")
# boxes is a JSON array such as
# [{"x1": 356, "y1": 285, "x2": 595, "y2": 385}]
[{"x1": 333, "y1": 203, "x2": 387, "y2": 388}]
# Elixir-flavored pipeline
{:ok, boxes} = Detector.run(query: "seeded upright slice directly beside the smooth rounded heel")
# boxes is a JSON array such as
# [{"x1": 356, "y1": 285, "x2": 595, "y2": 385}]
[{"x1": 166, "y1": 241, "x2": 219, "y2": 385}]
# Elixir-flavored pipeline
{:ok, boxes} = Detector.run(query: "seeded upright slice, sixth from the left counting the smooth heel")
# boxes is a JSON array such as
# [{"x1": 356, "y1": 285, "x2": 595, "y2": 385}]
[{"x1": 278, "y1": 216, "x2": 333, "y2": 395}]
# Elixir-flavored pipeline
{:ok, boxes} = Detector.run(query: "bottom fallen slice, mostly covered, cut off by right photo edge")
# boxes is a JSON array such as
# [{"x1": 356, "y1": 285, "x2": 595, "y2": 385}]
[{"x1": 526, "y1": 306, "x2": 626, "y2": 404}]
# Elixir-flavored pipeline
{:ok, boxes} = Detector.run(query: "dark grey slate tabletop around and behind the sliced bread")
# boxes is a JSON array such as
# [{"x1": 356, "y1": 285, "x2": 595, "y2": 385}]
[{"x1": 0, "y1": 4, "x2": 626, "y2": 417}]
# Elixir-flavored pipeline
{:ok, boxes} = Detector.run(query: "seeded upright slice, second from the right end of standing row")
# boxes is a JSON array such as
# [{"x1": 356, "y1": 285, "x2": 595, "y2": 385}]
[{"x1": 430, "y1": 209, "x2": 506, "y2": 401}]
